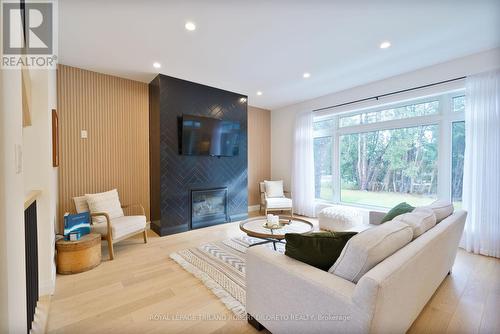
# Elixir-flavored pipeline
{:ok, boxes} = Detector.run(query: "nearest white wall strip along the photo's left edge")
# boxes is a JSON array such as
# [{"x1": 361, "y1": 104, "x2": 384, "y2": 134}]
[{"x1": 0, "y1": 70, "x2": 26, "y2": 333}]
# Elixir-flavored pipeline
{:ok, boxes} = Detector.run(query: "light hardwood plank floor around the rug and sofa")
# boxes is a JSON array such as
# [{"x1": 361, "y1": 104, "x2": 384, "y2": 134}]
[{"x1": 48, "y1": 217, "x2": 500, "y2": 333}]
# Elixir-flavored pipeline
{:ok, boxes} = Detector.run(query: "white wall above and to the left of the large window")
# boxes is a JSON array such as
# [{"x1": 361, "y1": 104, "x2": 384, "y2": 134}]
[{"x1": 271, "y1": 48, "x2": 500, "y2": 187}]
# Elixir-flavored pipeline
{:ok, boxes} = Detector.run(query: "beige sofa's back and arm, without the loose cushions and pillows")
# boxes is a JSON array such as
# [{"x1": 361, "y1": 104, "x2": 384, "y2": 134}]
[{"x1": 246, "y1": 211, "x2": 467, "y2": 333}]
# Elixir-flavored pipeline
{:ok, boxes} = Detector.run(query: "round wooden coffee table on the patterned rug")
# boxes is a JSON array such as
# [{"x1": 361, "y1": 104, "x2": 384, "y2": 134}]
[{"x1": 240, "y1": 216, "x2": 314, "y2": 249}]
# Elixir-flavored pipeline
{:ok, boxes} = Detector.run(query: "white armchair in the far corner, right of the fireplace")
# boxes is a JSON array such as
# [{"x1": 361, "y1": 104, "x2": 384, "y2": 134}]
[{"x1": 259, "y1": 181, "x2": 293, "y2": 217}]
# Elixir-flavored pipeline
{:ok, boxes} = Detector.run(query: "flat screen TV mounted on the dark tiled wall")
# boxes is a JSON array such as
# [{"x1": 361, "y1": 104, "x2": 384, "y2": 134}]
[{"x1": 181, "y1": 115, "x2": 240, "y2": 157}]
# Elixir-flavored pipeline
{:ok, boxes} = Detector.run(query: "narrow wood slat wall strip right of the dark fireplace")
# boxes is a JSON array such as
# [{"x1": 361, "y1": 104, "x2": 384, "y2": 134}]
[{"x1": 248, "y1": 106, "x2": 271, "y2": 205}]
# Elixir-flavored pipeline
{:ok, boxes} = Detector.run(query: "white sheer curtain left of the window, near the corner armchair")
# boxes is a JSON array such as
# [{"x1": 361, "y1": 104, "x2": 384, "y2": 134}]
[{"x1": 292, "y1": 112, "x2": 315, "y2": 217}]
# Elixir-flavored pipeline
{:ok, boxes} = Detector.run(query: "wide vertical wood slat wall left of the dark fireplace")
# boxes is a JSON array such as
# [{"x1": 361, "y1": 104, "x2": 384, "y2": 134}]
[{"x1": 57, "y1": 65, "x2": 149, "y2": 226}]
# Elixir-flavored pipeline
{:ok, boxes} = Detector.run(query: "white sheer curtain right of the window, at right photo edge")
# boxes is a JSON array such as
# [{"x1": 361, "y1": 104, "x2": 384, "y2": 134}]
[{"x1": 461, "y1": 70, "x2": 500, "y2": 257}]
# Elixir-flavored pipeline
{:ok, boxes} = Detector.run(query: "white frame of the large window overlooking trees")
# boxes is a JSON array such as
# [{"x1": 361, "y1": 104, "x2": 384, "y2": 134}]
[{"x1": 313, "y1": 88, "x2": 465, "y2": 210}]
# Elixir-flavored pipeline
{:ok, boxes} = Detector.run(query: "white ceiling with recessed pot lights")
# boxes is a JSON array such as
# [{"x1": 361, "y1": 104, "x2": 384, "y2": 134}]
[{"x1": 59, "y1": 0, "x2": 500, "y2": 109}]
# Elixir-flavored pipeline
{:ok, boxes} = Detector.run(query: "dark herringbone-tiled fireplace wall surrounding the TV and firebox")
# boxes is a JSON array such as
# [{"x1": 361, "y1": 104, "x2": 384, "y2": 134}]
[{"x1": 149, "y1": 74, "x2": 248, "y2": 236}]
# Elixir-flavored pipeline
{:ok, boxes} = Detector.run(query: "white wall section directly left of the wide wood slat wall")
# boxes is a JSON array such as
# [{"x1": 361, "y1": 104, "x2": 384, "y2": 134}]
[{"x1": 23, "y1": 69, "x2": 57, "y2": 295}]
